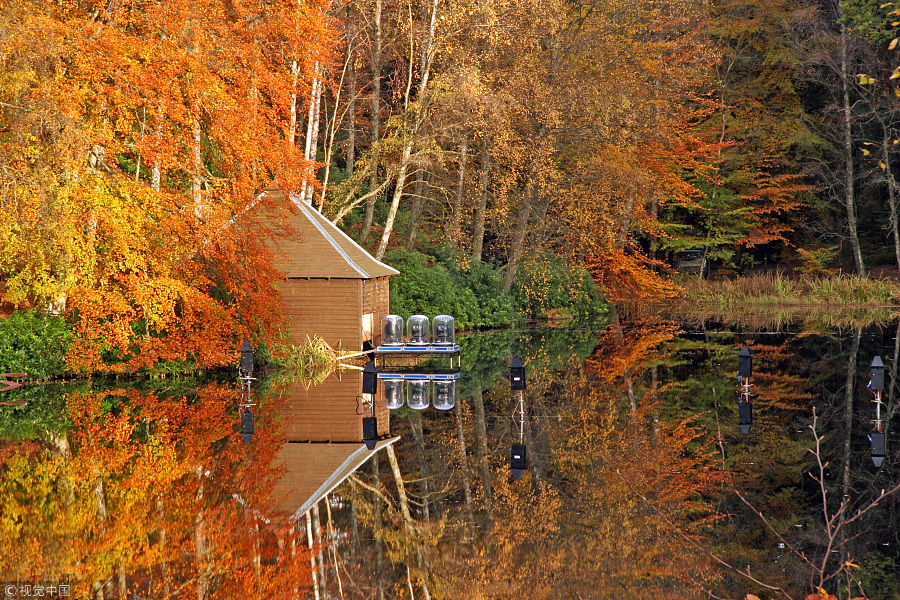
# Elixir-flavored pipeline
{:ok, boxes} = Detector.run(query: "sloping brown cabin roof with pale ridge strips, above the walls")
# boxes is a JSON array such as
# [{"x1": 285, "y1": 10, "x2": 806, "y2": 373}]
[{"x1": 263, "y1": 189, "x2": 399, "y2": 279}]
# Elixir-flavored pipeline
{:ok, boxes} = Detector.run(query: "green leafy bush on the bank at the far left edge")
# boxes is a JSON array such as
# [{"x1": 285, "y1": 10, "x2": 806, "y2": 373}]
[{"x1": 0, "y1": 310, "x2": 72, "y2": 379}]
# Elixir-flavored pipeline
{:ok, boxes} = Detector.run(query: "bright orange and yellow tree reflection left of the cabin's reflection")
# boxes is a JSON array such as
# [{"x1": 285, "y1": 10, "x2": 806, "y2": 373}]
[{"x1": 0, "y1": 385, "x2": 310, "y2": 598}]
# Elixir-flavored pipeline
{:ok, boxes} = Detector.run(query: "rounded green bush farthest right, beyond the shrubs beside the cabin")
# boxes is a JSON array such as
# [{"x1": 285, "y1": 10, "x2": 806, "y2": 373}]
[{"x1": 513, "y1": 254, "x2": 606, "y2": 316}]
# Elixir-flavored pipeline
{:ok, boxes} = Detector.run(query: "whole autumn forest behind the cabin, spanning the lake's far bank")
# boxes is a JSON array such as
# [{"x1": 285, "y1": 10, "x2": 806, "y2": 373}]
[{"x1": 0, "y1": 0, "x2": 900, "y2": 374}]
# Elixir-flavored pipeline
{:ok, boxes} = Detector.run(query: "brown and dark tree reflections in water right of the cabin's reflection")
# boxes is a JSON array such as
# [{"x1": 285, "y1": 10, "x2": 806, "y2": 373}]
[{"x1": 326, "y1": 318, "x2": 900, "y2": 598}]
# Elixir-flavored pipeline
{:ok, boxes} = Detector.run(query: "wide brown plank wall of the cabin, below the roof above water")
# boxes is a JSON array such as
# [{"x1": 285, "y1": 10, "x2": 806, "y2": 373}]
[{"x1": 280, "y1": 278, "x2": 363, "y2": 351}]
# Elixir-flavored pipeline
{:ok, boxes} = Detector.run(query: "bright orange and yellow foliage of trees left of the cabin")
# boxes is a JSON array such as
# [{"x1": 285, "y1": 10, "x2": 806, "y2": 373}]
[{"x1": 0, "y1": 0, "x2": 333, "y2": 370}]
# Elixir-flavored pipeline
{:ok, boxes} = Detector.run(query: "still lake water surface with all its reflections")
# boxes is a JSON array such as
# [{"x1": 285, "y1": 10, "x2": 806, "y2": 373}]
[{"x1": 0, "y1": 315, "x2": 900, "y2": 599}]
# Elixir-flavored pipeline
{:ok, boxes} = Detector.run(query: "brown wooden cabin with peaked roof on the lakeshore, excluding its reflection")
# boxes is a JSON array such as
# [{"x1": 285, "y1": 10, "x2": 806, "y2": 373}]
[{"x1": 263, "y1": 190, "x2": 398, "y2": 350}]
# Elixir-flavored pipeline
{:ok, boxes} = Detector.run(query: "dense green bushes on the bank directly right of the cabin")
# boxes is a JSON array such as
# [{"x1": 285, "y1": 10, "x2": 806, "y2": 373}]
[{"x1": 387, "y1": 249, "x2": 520, "y2": 329}]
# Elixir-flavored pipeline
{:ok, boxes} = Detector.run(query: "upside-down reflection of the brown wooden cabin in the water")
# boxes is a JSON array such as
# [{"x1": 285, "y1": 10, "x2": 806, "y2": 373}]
[{"x1": 275, "y1": 371, "x2": 399, "y2": 519}]
